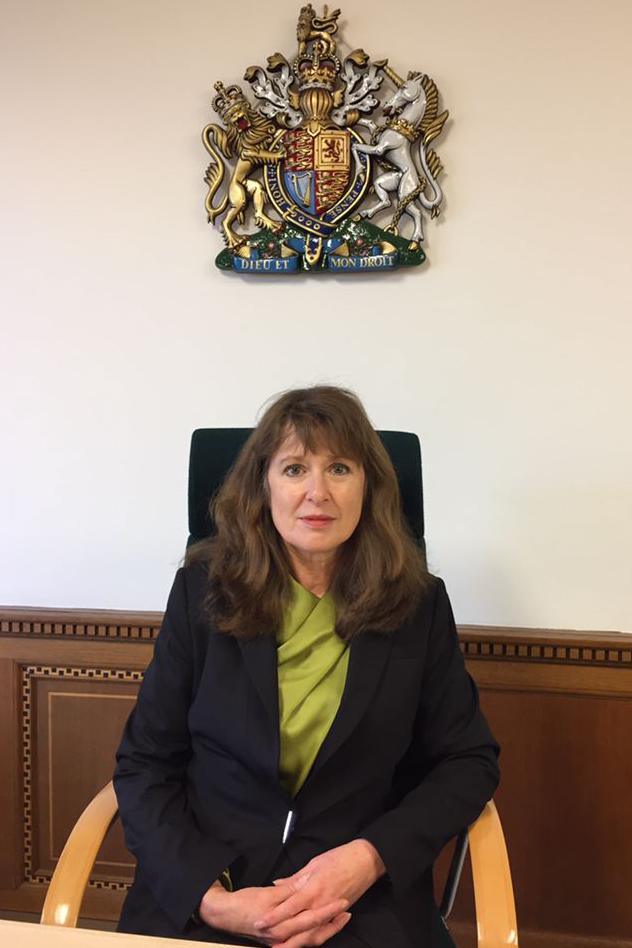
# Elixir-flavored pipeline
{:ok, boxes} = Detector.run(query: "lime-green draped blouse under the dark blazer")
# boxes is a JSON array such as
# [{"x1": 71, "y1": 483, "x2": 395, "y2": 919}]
[{"x1": 277, "y1": 578, "x2": 349, "y2": 796}]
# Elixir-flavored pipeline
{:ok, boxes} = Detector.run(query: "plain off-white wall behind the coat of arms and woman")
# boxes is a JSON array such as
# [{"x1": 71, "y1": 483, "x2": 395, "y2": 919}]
[{"x1": 0, "y1": 0, "x2": 632, "y2": 630}]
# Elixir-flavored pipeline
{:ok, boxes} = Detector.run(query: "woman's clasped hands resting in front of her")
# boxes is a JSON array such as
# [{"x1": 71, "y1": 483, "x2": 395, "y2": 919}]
[{"x1": 200, "y1": 839, "x2": 385, "y2": 948}]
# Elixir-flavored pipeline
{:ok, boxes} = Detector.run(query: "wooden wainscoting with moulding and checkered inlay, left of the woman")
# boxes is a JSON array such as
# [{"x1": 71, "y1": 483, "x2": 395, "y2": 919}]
[{"x1": 0, "y1": 610, "x2": 161, "y2": 920}]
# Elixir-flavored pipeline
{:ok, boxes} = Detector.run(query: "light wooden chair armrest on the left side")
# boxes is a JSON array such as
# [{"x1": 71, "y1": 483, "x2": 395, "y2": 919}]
[{"x1": 40, "y1": 781, "x2": 118, "y2": 928}]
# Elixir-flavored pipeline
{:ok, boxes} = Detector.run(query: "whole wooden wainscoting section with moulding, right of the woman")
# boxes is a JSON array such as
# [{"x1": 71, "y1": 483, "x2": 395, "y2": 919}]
[{"x1": 455, "y1": 629, "x2": 632, "y2": 946}]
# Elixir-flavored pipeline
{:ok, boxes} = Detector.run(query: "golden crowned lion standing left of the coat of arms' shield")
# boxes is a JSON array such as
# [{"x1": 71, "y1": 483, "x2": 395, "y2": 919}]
[{"x1": 202, "y1": 83, "x2": 285, "y2": 250}]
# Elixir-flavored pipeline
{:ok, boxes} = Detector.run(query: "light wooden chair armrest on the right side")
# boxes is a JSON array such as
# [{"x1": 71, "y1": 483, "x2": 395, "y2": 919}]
[{"x1": 468, "y1": 800, "x2": 518, "y2": 948}]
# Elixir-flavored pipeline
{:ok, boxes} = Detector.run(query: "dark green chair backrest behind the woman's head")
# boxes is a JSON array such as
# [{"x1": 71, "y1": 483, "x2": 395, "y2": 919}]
[{"x1": 187, "y1": 428, "x2": 424, "y2": 549}]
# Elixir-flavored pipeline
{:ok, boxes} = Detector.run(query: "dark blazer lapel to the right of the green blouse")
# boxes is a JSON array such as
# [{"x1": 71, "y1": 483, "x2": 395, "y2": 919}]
[{"x1": 299, "y1": 632, "x2": 391, "y2": 780}]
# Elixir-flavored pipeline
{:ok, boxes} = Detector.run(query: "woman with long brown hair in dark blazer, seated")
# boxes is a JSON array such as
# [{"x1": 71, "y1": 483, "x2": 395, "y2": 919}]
[{"x1": 115, "y1": 386, "x2": 498, "y2": 948}]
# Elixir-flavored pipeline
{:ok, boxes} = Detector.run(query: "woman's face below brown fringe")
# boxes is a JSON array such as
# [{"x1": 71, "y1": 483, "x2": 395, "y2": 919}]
[{"x1": 268, "y1": 435, "x2": 365, "y2": 561}]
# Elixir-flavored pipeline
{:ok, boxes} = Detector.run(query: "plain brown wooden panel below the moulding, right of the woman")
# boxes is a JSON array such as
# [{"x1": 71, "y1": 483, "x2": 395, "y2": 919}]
[{"x1": 483, "y1": 691, "x2": 632, "y2": 938}]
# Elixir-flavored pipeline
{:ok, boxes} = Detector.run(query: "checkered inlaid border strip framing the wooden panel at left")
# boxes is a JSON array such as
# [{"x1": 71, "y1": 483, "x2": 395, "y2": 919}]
[{"x1": 22, "y1": 665, "x2": 143, "y2": 891}]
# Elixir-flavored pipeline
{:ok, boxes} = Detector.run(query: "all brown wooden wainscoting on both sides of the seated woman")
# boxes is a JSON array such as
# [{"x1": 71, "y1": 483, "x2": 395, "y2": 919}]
[{"x1": 0, "y1": 609, "x2": 632, "y2": 948}]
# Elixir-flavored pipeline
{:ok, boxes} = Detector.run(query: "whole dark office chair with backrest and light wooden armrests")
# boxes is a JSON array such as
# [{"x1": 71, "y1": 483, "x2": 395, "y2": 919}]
[{"x1": 41, "y1": 428, "x2": 518, "y2": 948}]
